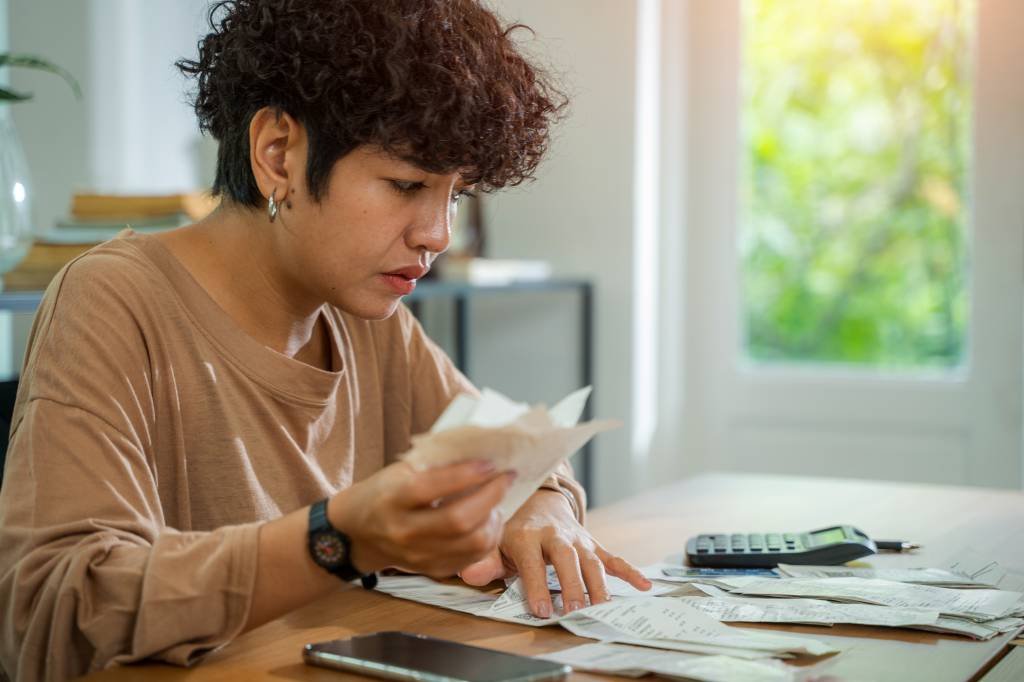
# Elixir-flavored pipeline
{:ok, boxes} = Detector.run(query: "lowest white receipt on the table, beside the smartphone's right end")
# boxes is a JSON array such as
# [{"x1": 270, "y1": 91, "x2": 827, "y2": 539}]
[{"x1": 538, "y1": 643, "x2": 798, "y2": 682}]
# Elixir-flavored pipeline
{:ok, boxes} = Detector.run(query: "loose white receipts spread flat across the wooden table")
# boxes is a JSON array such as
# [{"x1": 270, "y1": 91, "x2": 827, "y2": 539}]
[{"x1": 378, "y1": 562, "x2": 1024, "y2": 682}]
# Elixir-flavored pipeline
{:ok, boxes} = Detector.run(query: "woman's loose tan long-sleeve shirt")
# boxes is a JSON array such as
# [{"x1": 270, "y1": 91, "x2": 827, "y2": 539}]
[{"x1": 0, "y1": 235, "x2": 584, "y2": 680}]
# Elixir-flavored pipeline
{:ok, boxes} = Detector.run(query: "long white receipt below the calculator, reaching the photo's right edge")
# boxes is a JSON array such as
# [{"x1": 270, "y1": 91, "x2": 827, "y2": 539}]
[{"x1": 734, "y1": 578, "x2": 1024, "y2": 621}]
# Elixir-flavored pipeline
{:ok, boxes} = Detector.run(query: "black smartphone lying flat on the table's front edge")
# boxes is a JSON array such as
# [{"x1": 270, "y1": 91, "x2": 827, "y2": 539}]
[{"x1": 302, "y1": 632, "x2": 572, "y2": 682}]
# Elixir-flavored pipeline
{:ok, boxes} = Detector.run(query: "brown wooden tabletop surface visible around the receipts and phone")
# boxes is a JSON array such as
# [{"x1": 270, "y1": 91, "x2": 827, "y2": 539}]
[{"x1": 90, "y1": 474, "x2": 1024, "y2": 682}]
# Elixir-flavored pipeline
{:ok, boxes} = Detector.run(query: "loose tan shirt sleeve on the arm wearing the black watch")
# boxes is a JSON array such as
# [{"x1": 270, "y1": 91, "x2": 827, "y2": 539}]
[{"x1": 0, "y1": 256, "x2": 259, "y2": 680}]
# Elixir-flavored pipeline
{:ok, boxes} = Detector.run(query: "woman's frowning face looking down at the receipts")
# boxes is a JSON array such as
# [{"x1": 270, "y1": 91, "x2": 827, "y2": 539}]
[{"x1": 274, "y1": 141, "x2": 466, "y2": 319}]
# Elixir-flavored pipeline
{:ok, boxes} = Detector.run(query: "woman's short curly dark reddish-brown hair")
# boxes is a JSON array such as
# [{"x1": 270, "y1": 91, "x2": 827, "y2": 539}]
[{"x1": 175, "y1": 0, "x2": 567, "y2": 207}]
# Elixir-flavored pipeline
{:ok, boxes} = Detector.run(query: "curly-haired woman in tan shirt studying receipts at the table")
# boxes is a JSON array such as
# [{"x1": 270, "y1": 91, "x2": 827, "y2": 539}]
[{"x1": 0, "y1": 0, "x2": 649, "y2": 679}]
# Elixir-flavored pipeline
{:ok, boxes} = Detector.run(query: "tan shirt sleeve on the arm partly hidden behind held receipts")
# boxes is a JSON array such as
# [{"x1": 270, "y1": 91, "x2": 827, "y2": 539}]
[{"x1": 397, "y1": 306, "x2": 587, "y2": 523}]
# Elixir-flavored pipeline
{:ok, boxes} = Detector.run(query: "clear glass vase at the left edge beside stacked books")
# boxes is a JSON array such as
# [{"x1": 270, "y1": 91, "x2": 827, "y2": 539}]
[{"x1": 0, "y1": 103, "x2": 34, "y2": 291}]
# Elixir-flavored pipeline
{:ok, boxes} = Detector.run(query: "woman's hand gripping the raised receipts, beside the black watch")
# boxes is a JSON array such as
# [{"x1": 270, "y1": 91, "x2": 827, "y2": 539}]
[{"x1": 328, "y1": 460, "x2": 514, "y2": 578}]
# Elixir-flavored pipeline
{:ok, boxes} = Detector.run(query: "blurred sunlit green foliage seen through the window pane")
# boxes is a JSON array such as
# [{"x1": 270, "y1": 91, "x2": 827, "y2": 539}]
[{"x1": 739, "y1": 0, "x2": 975, "y2": 368}]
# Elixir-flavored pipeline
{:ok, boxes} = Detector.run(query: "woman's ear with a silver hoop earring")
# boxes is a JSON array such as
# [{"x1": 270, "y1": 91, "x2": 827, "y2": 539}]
[{"x1": 249, "y1": 106, "x2": 305, "y2": 201}]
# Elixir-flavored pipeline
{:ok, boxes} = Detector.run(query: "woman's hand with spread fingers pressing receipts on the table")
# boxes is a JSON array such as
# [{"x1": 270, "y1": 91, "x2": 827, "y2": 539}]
[{"x1": 459, "y1": 488, "x2": 650, "y2": 619}]
